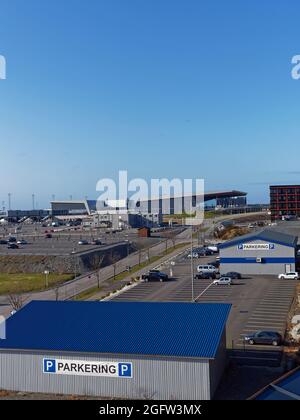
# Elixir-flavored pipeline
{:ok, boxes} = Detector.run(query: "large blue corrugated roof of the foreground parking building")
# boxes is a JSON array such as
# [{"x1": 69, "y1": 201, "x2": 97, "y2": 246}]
[{"x1": 0, "y1": 301, "x2": 231, "y2": 358}]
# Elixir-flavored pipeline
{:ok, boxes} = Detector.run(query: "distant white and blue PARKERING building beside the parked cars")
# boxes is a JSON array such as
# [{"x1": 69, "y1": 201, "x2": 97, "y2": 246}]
[{"x1": 219, "y1": 229, "x2": 298, "y2": 275}]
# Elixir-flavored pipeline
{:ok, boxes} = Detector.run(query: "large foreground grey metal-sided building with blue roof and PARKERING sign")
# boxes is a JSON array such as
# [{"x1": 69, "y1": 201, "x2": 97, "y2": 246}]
[{"x1": 0, "y1": 301, "x2": 230, "y2": 400}]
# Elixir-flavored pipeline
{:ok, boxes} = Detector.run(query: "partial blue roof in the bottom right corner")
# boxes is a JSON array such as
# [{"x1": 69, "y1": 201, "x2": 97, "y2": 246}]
[{"x1": 252, "y1": 368, "x2": 300, "y2": 400}]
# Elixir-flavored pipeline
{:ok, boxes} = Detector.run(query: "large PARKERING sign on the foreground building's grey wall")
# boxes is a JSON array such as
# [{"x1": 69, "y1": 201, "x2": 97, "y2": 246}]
[{"x1": 43, "y1": 359, "x2": 132, "y2": 378}]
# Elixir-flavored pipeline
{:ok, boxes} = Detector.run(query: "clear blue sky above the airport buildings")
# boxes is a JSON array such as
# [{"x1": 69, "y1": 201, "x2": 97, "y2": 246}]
[{"x1": 0, "y1": 0, "x2": 300, "y2": 208}]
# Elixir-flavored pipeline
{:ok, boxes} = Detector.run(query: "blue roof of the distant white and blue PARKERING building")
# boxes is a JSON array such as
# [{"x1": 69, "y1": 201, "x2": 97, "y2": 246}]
[{"x1": 219, "y1": 229, "x2": 298, "y2": 248}]
